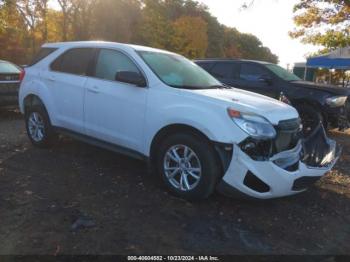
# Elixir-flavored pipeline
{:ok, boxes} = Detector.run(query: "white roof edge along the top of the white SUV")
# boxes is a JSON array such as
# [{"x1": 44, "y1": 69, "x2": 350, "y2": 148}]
[{"x1": 43, "y1": 41, "x2": 171, "y2": 53}]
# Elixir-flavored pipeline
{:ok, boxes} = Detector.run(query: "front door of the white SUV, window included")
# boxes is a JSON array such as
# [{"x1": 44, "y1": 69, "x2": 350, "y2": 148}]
[{"x1": 85, "y1": 49, "x2": 148, "y2": 151}]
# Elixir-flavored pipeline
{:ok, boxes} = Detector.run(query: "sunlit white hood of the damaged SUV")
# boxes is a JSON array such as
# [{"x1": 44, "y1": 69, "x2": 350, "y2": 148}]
[{"x1": 186, "y1": 88, "x2": 299, "y2": 125}]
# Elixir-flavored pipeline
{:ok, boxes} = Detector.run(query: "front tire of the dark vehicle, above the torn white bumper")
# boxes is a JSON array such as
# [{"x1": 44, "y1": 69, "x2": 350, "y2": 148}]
[{"x1": 296, "y1": 105, "x2": 327, "y2": 136}]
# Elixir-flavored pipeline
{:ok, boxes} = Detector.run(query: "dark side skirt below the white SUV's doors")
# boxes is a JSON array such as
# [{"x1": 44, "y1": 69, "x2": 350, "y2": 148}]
[{"x1": 54, "y1": 127, "x2": 149, "y2": 162}]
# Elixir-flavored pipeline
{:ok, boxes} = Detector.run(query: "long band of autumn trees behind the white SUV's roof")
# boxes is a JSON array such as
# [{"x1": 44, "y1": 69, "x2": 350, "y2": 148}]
[{"x1": 0, "y1": 0, "x2": 278, "y2": 63}]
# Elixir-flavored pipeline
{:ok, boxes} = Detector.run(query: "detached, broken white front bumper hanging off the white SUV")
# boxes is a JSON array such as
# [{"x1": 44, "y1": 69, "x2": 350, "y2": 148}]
[{"x1": 218, "y1": 125, "x2": 341, "y2": 199}]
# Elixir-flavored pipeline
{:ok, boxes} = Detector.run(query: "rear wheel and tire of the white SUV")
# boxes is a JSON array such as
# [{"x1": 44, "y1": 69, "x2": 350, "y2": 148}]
[{"x1": 25, "y1": 105, "x2": 57, "y2": 148}]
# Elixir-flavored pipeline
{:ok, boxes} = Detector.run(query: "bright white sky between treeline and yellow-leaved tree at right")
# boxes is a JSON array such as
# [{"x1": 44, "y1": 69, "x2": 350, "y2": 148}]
[{"x1": 200, "y1": 0, "x2": 318, "y2": 68}]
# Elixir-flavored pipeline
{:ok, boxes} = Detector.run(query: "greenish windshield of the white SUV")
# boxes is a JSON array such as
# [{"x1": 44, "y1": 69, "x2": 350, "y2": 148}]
[{"x1": 138, "y1": 51, "x2": 222, "y2": 89}]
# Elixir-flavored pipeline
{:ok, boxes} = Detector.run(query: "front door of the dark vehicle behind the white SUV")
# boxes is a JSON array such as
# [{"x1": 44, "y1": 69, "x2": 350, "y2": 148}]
[{"x1": 236, "y1": 62, "x2": 278, "y2": 98}]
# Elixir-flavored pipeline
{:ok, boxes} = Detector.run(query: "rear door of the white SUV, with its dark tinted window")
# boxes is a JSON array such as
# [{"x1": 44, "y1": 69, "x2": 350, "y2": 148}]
[{"x1": 42, "y1": 48, "x2": 96, "y2": 134}]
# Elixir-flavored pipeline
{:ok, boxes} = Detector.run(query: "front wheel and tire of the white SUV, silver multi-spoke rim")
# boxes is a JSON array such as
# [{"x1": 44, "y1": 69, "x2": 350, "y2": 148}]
[{"x1": 155, "y1": 134, "x2": 221, "y2": 201}]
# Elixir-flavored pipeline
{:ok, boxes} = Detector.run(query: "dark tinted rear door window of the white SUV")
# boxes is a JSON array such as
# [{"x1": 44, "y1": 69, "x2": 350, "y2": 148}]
[{"x1": 51, "y1": 48, "x2": 95, "y2": 76}]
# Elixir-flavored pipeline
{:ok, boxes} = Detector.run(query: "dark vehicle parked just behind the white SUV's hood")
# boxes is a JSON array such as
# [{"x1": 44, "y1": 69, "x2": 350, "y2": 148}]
[{"x1": 195, "y1": 59, "x2": 350, "y2": 133}]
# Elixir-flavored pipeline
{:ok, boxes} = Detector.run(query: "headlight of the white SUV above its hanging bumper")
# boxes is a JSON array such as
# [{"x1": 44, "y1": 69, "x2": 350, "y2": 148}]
[{"x1": 228, "y1": 108, "x2": 276, "y2": 140}]
